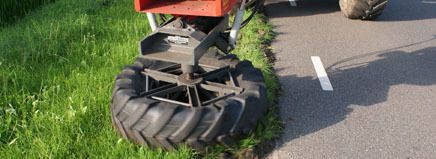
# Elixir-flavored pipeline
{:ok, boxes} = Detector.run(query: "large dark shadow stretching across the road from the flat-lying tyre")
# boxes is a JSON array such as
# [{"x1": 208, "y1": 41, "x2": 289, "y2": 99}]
[{"x1": 276, "y1": 42, "x2": 436, "y2": 153}]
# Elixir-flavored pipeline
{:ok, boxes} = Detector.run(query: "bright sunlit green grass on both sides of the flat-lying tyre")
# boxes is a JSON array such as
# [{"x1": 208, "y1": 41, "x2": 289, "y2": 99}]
[{"x1": 0, "y1": 0, "x2": 280, "y2": 159}]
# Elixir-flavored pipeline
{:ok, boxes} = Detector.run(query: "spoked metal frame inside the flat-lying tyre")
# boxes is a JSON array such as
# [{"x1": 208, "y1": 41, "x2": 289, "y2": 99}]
[{"x1": 141, "y1": 64, "x2": 243, "y2": 107}]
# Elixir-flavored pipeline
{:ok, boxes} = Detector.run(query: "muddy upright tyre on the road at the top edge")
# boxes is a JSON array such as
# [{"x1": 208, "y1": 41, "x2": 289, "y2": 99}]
[{"x1": 339, "y1": 0, "x2": 388, "y2": 20}]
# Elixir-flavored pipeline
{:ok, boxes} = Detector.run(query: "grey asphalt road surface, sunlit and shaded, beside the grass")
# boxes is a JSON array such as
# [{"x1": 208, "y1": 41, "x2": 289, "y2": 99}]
[{"x1": 266, "y1": 0, "x2": 436, "y2": 159}]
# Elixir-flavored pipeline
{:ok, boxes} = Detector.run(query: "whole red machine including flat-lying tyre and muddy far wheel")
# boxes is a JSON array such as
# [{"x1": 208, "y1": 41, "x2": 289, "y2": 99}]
[{"x1": 110, "y1": 0, "x2": 387, "y2": 152}]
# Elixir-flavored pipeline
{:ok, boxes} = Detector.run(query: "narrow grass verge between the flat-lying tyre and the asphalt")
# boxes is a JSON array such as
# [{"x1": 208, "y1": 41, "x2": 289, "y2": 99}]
[{"x1": 212, "y1": 11, "x2": 282, "y2": 158}]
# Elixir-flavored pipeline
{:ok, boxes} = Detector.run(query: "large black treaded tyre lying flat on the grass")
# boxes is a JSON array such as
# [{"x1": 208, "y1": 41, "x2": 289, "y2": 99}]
[{"x1": 110, "y1": 53, "x2": 268, "y2": 152}]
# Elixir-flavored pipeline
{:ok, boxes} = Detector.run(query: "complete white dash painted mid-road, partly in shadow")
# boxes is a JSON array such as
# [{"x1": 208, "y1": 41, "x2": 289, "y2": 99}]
[{"x1": 310, "y1": 56, "x2": 333, "y2": 91}]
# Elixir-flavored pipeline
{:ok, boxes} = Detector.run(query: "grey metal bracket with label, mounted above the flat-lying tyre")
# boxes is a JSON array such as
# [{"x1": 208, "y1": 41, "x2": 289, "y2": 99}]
[{"x1": 140, "y1": 16, "x2": 228, "y2": 74}]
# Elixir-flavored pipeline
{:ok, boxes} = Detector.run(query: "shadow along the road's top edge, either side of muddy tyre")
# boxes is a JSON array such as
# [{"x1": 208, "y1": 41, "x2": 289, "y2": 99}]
[{"x1": 265, "y1": 0, "x2": 436, "y2": 21}]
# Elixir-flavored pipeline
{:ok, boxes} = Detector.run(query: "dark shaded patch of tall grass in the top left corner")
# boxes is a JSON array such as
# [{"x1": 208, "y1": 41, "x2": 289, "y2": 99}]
[{"x1": 0, "y1": 0, "x2": 55, "y2": 26}]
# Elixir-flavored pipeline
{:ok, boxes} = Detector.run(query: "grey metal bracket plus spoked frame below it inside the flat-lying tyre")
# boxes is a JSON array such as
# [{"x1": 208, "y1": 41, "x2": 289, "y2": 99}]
[{"x1": 139, "y1": 0, "x2": 253, "y2": 107}]
